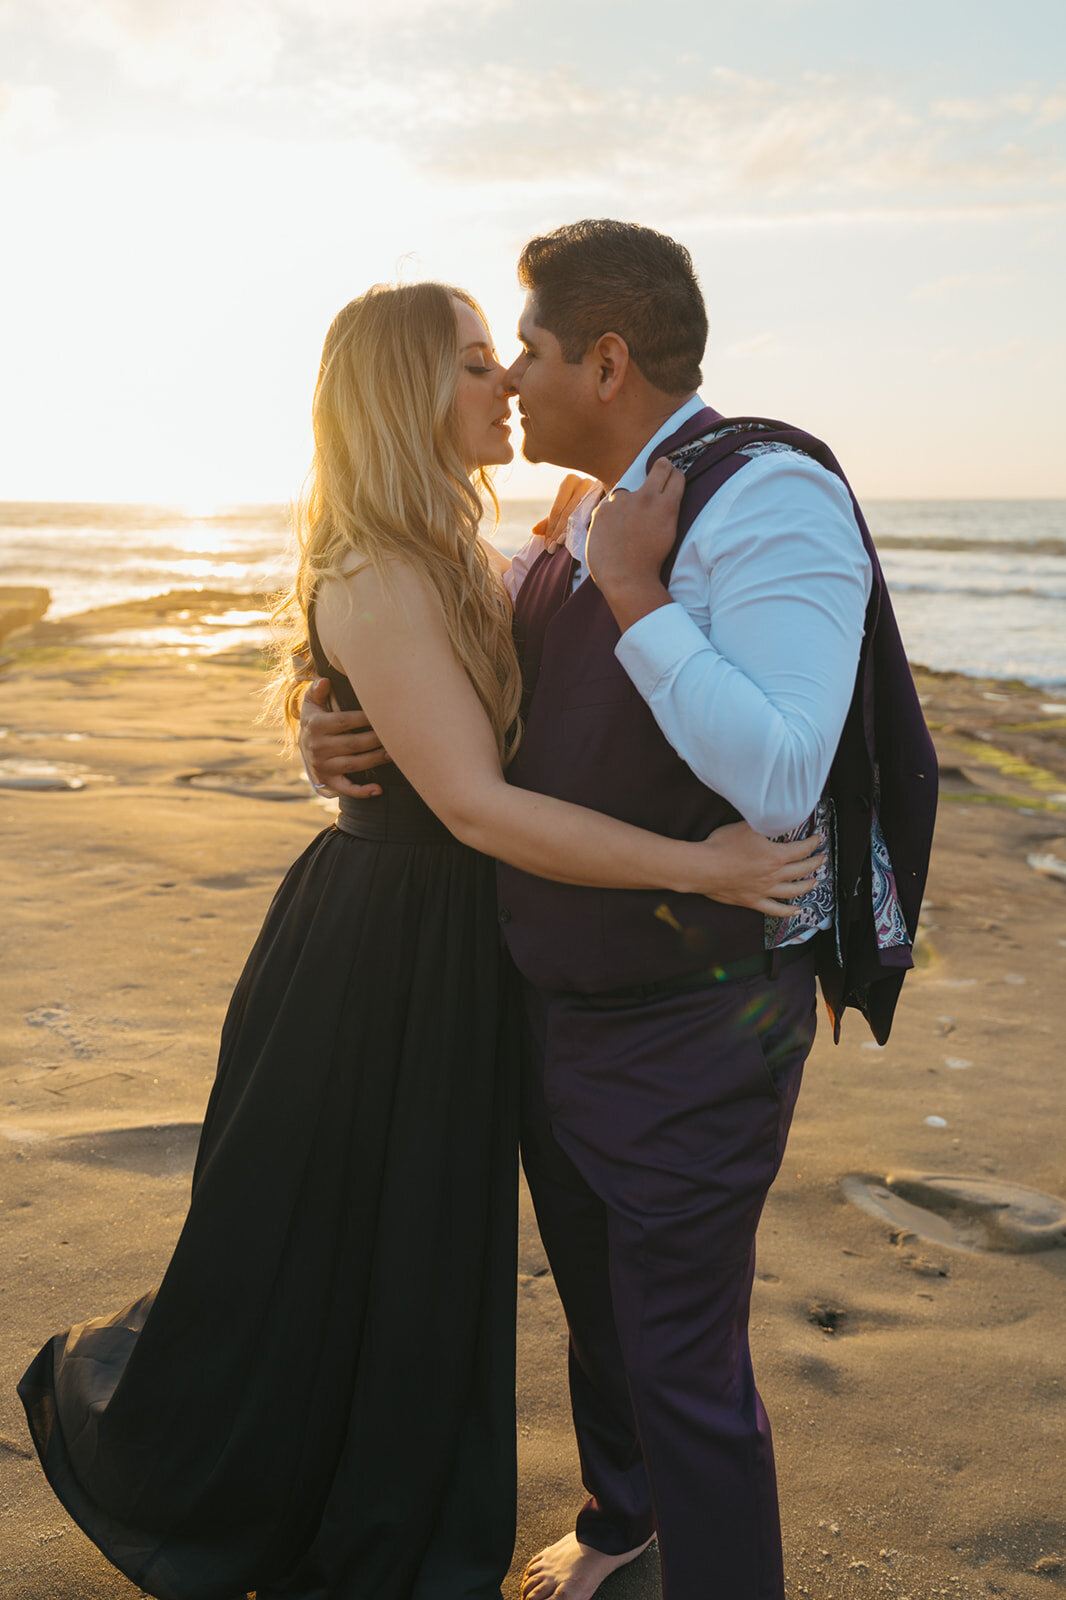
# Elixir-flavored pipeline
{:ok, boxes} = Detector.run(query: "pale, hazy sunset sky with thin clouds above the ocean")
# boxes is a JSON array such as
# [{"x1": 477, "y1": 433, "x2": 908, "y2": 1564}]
[{"x1": 0, "y1": 0, "x2": 1066, "y2": 509}]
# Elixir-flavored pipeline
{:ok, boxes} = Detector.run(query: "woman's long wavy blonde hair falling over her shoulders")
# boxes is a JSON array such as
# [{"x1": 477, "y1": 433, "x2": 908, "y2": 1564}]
[{"x1": 267, "y1": 283, "x2": 522, "y2": 763}]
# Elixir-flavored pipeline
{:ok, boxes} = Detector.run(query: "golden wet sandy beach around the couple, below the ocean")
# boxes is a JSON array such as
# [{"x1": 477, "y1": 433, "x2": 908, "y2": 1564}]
[{"x1": 0, "y1": 592, "x2": 1066, "y2": 1600}]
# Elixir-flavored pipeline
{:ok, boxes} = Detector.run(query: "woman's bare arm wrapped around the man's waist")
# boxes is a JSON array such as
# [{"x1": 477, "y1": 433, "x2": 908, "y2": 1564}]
[{"x1": 315, "y1": 563, "x2": 821, "y2": 915}]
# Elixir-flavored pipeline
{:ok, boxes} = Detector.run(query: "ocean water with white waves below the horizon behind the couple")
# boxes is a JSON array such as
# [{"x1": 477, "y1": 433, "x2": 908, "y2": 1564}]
[{"x1": 0, "y1": 499, "x2": 1066, "y2": 690}]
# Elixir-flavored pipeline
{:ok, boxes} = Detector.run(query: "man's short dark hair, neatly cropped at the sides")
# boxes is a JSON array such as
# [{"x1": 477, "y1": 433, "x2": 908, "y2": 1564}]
[{"x1": 519, "y1": 219, "x2": 707, "y2": 395}]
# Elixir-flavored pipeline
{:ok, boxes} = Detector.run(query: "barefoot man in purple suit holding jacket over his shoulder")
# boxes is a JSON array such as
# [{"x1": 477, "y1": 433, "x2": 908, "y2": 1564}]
[{"x1": 304, "y1": 222, "x2": 935, "y2": 1600}]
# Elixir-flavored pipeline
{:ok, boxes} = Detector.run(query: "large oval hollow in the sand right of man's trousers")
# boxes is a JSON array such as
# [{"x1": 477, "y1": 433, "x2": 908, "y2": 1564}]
[{"x1": 840, "y1": 1171, "x2": 1066, "y2": 1254}]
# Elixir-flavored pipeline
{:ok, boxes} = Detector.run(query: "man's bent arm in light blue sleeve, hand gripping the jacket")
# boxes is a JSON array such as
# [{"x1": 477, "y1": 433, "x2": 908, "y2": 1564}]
[{"x1": 589, "y1": 453, "x2": 871, "y2": 834}]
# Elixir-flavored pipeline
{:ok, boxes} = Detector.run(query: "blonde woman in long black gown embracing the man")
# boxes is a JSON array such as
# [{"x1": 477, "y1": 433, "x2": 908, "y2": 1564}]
[{"x1": 21, "y1": 283, "x2": 818, "y2": 1600}]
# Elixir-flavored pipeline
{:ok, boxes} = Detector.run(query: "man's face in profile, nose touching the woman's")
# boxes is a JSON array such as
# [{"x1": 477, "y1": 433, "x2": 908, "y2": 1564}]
[{"x1": 507, "y1": 296, "x2": 599, "y2": 467}]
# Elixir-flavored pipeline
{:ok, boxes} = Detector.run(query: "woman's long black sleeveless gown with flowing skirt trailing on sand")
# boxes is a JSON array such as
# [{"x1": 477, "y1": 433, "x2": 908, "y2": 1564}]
[{"x1": 19, "y1": 611, "x2": 517, "y2": 1600}]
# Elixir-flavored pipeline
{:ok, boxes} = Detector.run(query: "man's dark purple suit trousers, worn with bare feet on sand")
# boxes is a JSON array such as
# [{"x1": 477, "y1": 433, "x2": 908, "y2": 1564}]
[{"x1": 522, "y1": 957, "x2": 815, "y2": 1600}]
